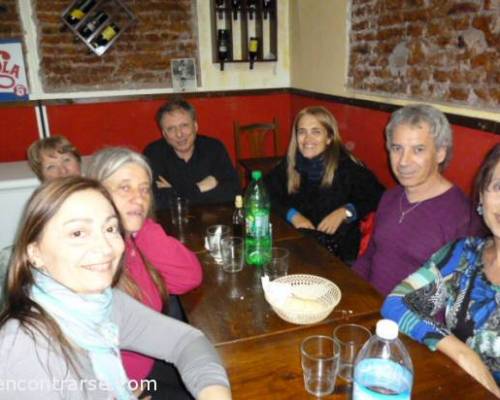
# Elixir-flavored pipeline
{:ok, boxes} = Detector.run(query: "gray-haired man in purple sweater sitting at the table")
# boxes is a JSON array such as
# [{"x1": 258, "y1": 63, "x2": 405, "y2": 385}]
[{"x1": 353, "y1": 105, "x2": 480, "y2": 296}]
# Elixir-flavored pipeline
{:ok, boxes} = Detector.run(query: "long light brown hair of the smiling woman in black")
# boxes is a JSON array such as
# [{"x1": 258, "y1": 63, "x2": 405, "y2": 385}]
[{"x1": 287, "y1": 106, "x2": 360, "y2": 194}]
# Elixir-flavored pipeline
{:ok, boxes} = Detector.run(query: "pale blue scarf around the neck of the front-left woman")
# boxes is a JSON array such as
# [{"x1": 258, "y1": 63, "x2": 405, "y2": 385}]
[{"x1": 30, "y1": 270, "x2": 135, "y2": 400}]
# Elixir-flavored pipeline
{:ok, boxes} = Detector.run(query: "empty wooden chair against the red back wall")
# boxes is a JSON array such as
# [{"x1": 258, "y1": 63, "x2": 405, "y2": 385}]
[{"x1": 234, "y1": 117, "x2": 281, "y2": 187}]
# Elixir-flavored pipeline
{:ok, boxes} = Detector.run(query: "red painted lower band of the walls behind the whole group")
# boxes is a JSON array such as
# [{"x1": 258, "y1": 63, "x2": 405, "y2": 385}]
[{"x1": 0, "y1": 92, "x2": 500, "y2": 198}]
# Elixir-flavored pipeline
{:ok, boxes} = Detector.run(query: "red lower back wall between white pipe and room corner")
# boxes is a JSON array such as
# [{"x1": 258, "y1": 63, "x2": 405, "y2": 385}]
[{"x1": 47, "y1": 93, "x2": 290, "y2": 164}]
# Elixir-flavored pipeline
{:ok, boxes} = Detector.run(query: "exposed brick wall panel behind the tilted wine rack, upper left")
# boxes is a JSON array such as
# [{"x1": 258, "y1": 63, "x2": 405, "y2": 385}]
[{"x1": 34, "y1": 0, "x2": 198, "y2": 92}]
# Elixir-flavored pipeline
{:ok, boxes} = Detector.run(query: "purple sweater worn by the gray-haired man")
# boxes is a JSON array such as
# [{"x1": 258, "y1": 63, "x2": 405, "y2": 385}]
[{"x1": 353, "y1": 186, "x2": 481, "y2": 296}]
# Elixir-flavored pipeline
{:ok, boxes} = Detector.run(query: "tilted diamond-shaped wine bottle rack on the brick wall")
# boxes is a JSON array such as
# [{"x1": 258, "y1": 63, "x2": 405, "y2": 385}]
[{"x1": 61, "y1": 0, "x2": 136, "y2": 56}]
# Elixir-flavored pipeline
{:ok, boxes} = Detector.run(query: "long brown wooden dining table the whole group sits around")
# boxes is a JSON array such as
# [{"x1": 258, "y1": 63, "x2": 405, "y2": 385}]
[{"x1": 159, "y1": 205, "x2": 492, "y2": 400}]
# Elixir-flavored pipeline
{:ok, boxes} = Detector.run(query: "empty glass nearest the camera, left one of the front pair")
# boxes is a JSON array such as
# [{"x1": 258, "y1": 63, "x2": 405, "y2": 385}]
[{"x1": 300, "y1": 336, "x2": 339, "y2": 397}]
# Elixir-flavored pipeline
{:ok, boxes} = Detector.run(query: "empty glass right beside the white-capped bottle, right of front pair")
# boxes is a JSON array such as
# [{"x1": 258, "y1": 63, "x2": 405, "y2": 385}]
[{"x1": 333, "y1": 324, "x2": 372, "y2": 382}]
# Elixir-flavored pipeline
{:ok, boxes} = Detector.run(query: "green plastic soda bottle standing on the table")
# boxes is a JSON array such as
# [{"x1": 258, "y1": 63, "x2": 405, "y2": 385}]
[{"x1": 244, "y1": 171, "x2": 272, "y2": 267}]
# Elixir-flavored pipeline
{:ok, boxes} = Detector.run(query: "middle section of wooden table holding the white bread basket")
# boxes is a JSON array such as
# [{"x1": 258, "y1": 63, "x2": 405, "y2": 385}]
[{"x1": 181, "y1": 237, "x2": 382, "y2": 344}]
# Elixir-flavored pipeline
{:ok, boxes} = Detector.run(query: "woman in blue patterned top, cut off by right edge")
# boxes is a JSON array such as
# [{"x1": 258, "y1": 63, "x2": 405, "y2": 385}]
[{"x1": 382, "y1": 144, "x2": 500, "y2": 398}]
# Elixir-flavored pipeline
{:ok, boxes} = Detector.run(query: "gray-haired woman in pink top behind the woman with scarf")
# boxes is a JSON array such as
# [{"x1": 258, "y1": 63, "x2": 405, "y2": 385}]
[{"x1": 87, "y1": 147, "x2": 202, "y2": 399}]
